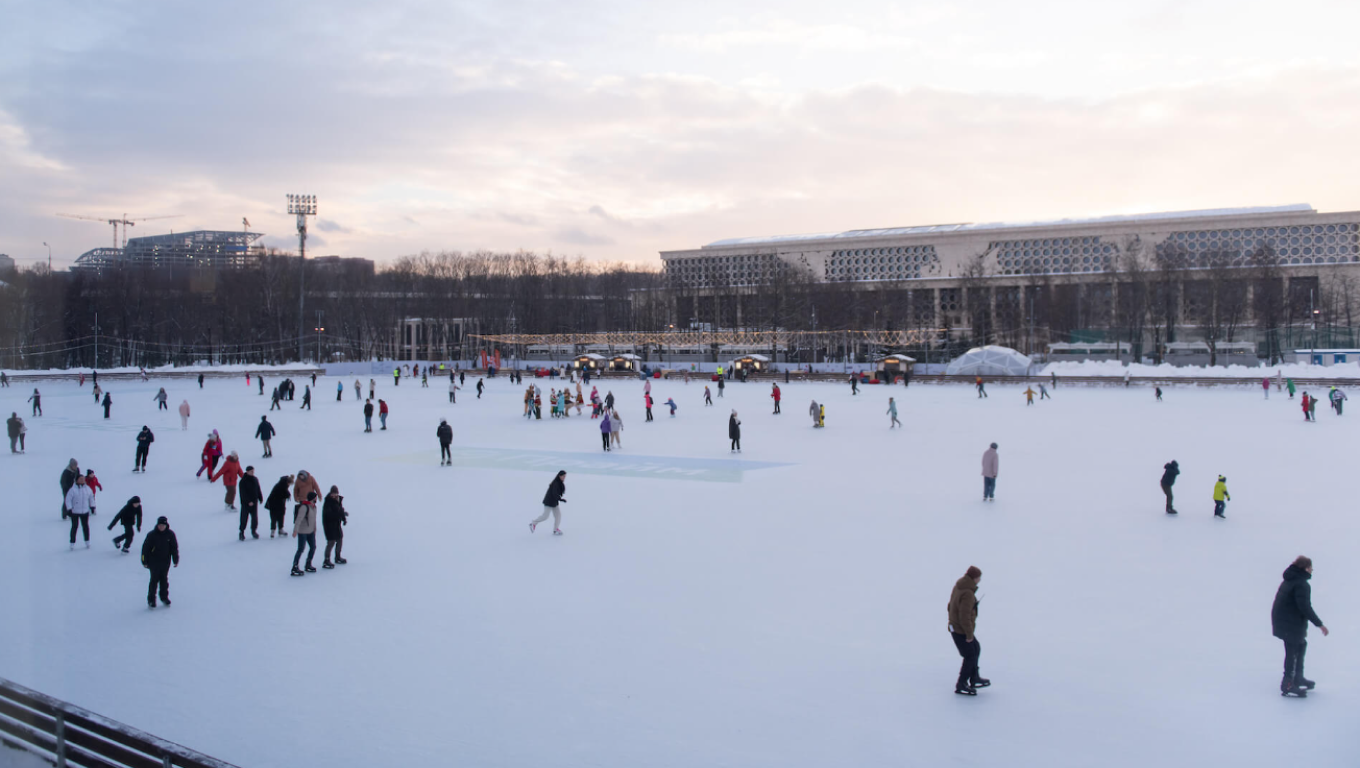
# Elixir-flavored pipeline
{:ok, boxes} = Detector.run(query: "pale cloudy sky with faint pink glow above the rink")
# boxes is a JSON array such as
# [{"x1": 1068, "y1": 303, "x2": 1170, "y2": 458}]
[{"x1": 0, "y1": 0, "x2": 1360, "y2": 268}]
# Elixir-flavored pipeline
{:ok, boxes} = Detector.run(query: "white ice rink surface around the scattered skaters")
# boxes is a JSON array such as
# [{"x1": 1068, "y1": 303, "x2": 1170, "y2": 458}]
[{"x1": 0, "y1": 378, "x2": 1360, "y2": 768}]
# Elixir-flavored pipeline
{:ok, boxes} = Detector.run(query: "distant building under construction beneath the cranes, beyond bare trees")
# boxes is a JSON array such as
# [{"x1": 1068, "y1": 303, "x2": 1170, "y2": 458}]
[{"x1": 72, "y1": 230, "x2": 264, "y2": 272}]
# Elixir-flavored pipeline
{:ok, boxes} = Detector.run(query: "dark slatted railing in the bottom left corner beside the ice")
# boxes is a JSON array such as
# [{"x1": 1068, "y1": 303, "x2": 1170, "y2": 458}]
[{"x1": 0, "y1": 678, "x2": 235, "y2": 768}]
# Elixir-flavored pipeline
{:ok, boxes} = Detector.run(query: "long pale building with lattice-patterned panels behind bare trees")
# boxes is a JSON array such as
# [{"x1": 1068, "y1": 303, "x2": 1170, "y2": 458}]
[{"x1": 661, "y1": 205, "x2": 1360, "y2": 353}]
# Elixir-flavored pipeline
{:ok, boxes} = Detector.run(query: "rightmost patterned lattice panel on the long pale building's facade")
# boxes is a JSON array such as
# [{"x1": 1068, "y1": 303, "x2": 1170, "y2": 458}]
[{"x1": 1157, "y1": 224, "x2": 1360, "y2": 269}]
